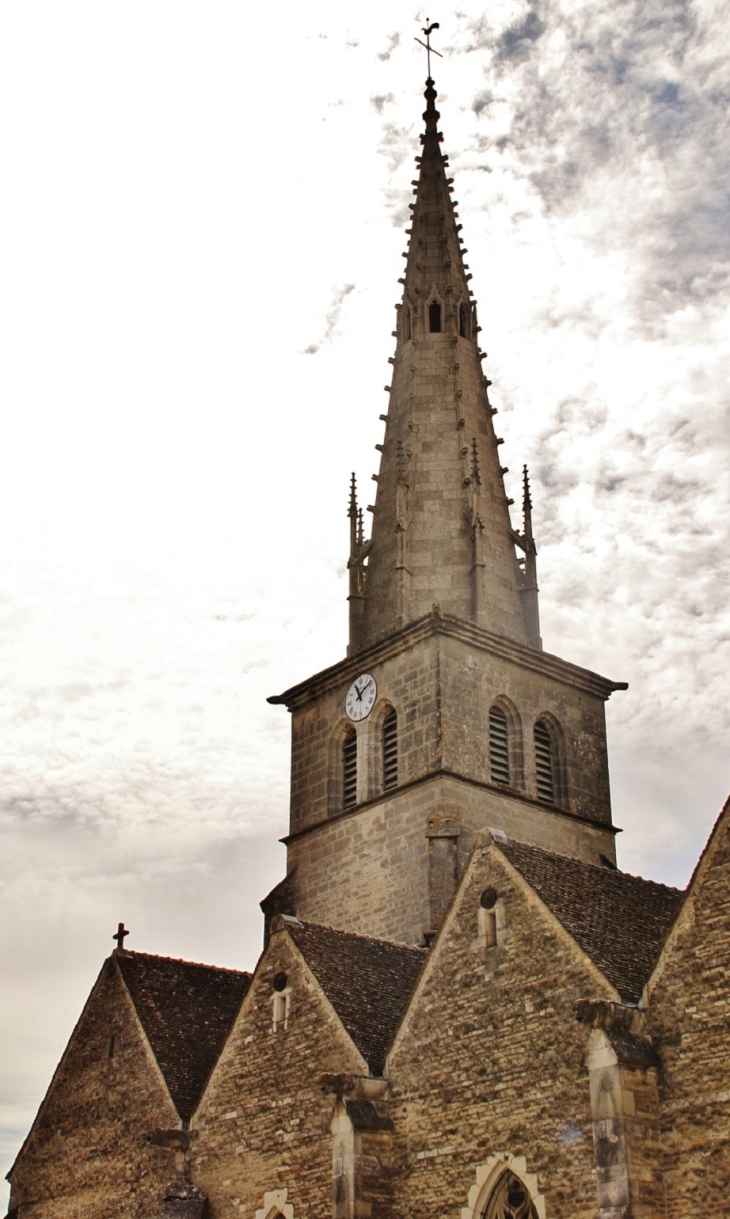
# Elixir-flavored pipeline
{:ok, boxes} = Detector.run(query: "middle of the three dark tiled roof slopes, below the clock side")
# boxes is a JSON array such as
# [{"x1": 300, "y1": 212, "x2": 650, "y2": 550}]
[{"x1": 286, "y1": 923, "x2": 428, "y2": 1075}]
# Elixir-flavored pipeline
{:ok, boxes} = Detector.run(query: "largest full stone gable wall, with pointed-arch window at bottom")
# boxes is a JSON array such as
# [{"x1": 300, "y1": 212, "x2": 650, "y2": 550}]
[{"x1": 388, "y1": 847, "x2": 615, "y2": 1219}]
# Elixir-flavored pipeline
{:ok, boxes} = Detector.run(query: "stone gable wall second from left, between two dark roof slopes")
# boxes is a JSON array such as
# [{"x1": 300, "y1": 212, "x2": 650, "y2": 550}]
[{"x1": 193, "y1": 923, "x2": 367, "y2": 1219}]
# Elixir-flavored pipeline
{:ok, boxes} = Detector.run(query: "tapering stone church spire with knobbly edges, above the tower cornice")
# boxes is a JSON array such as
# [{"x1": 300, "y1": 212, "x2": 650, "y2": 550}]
[{"x1": 350, "y1": 76, "x2": 540, "y2": 652}]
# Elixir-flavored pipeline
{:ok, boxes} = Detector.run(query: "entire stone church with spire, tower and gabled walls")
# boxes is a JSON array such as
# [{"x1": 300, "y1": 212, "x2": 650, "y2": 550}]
[{"x1": 10, "y1": 78, "x2": 730, "y2": 1219}]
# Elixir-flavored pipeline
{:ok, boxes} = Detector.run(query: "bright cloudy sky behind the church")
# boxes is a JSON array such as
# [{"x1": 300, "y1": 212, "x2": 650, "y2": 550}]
[{"x1": 0, "y1": 0, "x2": 730, "y2": 1199}]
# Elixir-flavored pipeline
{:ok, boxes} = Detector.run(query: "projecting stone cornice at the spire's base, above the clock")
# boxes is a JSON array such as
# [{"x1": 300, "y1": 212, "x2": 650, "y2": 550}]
[{"x1": 267, "y1": 611, "x2": 629, "y2": 711}]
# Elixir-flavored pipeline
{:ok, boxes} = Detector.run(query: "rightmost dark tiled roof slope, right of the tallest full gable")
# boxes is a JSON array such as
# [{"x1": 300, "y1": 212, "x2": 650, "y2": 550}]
[{"x1": 496, "y1": 842, "x2": 684, "y2": 1003}]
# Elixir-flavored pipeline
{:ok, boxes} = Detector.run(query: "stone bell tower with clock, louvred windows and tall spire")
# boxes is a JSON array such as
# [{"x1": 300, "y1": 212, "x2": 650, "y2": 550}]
[{"x1": 268, "y1": 78, "x2": 625, "y2": 944}]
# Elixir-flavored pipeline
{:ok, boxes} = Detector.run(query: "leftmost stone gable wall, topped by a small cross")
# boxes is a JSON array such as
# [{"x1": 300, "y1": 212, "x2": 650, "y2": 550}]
[{"x1": 11, "y1": 957, "x2": 179, "y2": 1219}]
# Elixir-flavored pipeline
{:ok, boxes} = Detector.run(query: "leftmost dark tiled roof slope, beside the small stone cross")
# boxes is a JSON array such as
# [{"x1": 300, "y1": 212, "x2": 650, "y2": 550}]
[{"x1": 116, "y1": 952, "x2": 251, "y2": 1121}]
